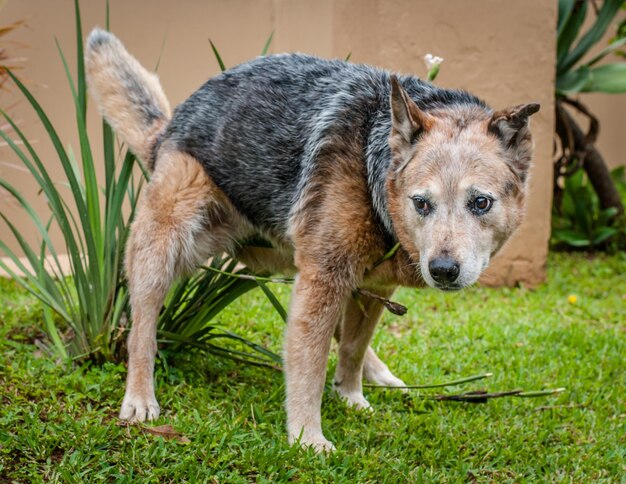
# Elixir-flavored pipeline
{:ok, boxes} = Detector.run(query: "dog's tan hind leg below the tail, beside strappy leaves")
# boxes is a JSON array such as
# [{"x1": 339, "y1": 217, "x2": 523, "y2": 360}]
[{"x1": 120, "y1": 151, "x2": 233, "y2": 421}]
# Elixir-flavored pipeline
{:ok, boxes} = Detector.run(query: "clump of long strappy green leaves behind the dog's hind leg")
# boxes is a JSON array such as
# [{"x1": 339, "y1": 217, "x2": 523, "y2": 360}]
[{"x1": 0, "y1": 0, "x2": 280, "y2": 366}]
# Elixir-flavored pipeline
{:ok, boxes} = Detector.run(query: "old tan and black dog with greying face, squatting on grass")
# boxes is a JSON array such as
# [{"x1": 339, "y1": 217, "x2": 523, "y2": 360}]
[{"x1": 85, "y1": 29, "x2": 539, "y2": 451}]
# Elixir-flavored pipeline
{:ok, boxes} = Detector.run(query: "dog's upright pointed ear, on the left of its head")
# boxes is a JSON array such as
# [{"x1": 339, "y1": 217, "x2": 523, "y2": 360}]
[{"x1": 389, "y1": 75, "x2": 433, "y2": 172}]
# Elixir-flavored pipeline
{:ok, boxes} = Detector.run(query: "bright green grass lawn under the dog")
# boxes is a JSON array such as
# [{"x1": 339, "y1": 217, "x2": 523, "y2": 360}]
[{"x1": 0, "y1": 253, "x2": 626, "y2": 482}]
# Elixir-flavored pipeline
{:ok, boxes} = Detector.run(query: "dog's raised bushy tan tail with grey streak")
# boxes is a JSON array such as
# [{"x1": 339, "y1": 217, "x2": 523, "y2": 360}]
[{"x1": 85, "y1": 29, "x2": 170, "y2": 165}]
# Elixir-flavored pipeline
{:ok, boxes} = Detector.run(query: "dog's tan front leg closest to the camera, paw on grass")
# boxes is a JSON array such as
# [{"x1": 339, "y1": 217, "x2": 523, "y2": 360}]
[{"x1": 285, "y1": 272, "x2": 345, "y2": 451}]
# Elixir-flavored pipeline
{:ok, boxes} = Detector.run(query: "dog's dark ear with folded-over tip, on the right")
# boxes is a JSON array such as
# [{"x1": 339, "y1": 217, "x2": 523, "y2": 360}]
[{"x1": 487, "y1": 103, "x2": 540, "y2": 181}]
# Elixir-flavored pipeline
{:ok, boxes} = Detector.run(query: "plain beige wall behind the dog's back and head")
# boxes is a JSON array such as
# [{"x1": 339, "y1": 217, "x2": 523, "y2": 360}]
[{"x1": 0, "y1": 0, "x2": 556, "y2": 284}]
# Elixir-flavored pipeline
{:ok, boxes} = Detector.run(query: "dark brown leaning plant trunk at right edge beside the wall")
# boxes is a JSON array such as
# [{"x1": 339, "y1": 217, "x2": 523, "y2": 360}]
[{"x1": 556, "y1": 102, "x2": 624, "y2": 215}]
